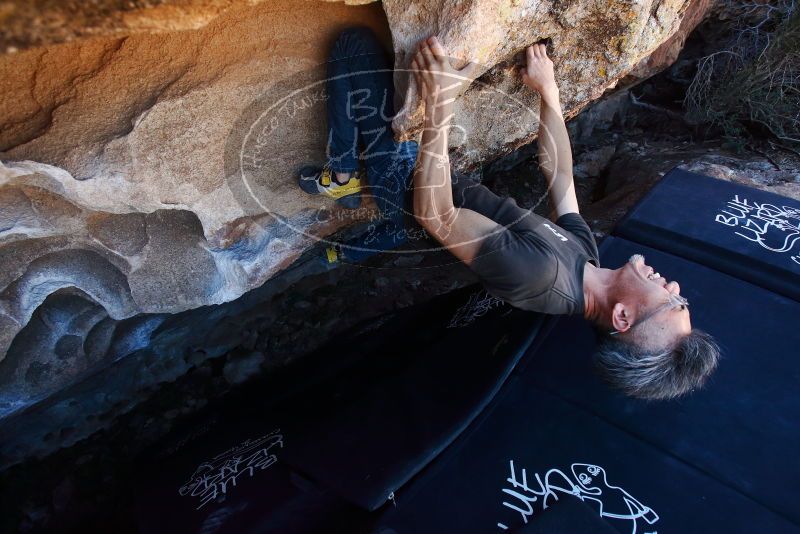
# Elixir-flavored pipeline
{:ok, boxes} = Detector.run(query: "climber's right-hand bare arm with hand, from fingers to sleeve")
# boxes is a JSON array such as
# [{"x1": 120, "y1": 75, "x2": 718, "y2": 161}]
[{"x1": 521, "y1": 44, "x2": 578, "y2": 218}]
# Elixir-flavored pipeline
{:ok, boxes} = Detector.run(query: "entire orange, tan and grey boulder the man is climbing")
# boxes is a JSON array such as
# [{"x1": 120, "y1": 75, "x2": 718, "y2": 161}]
[{"x1": 0, "y1": 0, "x2": 705, "y2": 468}]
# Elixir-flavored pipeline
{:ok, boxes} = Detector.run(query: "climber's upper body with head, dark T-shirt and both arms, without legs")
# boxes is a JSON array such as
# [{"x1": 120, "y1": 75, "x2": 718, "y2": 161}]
[{"x1": 411, "y1": 37, "x2": 719, "y2": 399}]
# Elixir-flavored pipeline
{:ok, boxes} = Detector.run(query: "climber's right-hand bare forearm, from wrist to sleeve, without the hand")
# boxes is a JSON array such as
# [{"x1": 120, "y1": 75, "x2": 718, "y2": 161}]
[{"x1": 538, "y1": 90, "x2": 578, "y2": 217}]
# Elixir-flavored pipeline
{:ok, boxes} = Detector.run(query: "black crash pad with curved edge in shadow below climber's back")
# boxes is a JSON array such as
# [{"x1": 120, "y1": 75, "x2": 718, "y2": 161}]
[{"x1": 276, "y1": 289, "x2": 549, "y2": 510}]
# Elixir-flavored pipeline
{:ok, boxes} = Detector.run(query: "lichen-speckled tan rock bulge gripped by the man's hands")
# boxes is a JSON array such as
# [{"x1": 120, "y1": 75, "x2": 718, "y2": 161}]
[{"x1": 383, "y1": 0, "x2": 709, "y2": 165}]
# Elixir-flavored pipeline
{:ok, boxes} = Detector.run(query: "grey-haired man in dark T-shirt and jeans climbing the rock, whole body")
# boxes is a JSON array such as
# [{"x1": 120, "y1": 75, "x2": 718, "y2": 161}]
[{"x1": 300, "y1": 29, "x2": 719, "y2": 399}]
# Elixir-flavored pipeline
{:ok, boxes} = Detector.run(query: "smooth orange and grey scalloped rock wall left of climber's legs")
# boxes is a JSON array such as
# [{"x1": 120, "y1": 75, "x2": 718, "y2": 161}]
[{"x1": 0, "y1": 2, "x2": 388, "y2": 413}]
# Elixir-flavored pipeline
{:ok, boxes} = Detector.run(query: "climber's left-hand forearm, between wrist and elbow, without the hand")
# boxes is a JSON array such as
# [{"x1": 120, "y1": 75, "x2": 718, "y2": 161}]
[{"x1": 414, "y1": 102, "x2": 454, "y2": 228}]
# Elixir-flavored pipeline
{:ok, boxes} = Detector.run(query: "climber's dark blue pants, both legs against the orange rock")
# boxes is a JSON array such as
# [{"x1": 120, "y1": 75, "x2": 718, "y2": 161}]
[{"x1": 326, "y1": 28, "x2": 417, "y2": 261}]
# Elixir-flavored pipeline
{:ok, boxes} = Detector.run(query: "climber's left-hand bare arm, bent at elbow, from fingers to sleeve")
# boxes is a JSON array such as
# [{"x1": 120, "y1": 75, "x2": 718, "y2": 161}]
[{"x1": 411, "y1": 37, "x2": 501, "y2": 265}]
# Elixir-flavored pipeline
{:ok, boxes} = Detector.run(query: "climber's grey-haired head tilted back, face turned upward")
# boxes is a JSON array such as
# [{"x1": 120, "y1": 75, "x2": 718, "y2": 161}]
[{"x1": 596, "y1": 254, "x2": 719, "y2": 399}]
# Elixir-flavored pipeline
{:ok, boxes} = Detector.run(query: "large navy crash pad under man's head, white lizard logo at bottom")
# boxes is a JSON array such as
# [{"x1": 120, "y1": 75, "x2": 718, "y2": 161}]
[{"x1": 378, "y1": 237, "x2": 800, "y2": 533}]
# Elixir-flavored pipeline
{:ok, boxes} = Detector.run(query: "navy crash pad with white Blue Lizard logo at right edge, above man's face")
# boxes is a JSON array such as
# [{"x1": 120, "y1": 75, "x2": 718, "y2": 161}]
[{"x1": 613, "y1": 168, "x2": 800, "y2": 301}]
